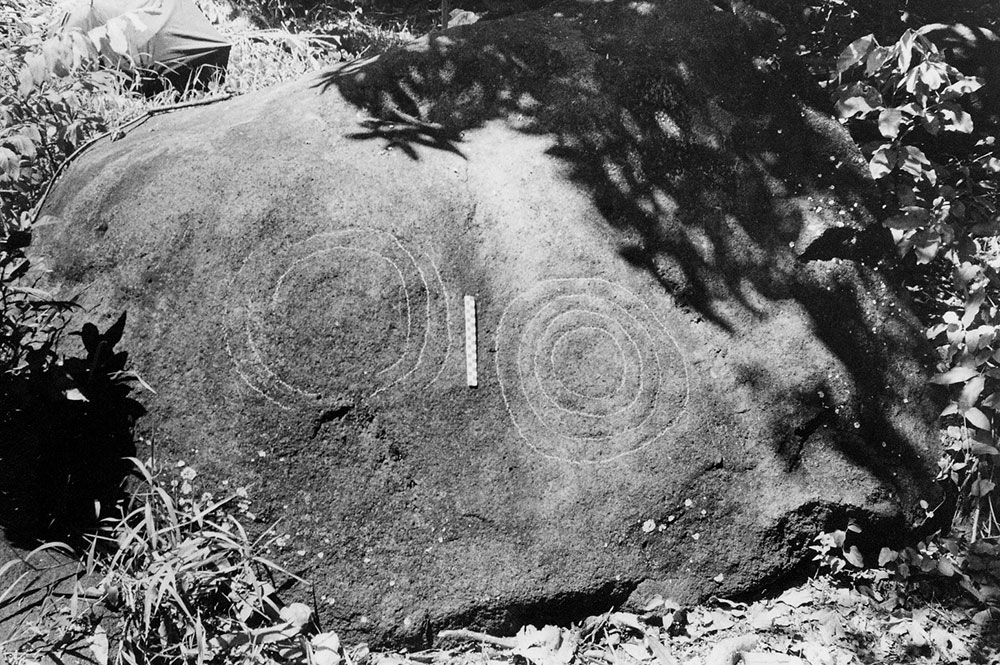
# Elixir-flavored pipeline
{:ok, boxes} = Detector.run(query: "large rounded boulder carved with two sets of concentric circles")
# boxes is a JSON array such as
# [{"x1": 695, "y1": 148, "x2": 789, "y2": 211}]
[{"x1": 25, "y1": 0, "x2": 934, "y2": 642}]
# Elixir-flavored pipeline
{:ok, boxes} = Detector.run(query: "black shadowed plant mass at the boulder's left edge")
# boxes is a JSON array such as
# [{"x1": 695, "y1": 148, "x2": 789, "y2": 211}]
[{"x1": 0, "y1": 314, "x2": 144, "y2": 548}]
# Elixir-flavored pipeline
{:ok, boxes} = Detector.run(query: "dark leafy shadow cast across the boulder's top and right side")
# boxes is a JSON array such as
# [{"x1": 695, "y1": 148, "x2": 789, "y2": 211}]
[{"x1": 319, "y1": 2, "x2": 933, "y2": 508}]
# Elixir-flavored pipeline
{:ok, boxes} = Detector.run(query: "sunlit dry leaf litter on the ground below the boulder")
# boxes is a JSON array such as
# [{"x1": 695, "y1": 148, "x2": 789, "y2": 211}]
[{"x1": 396, "y1": 577, "x2": 1000, "y2": 665}]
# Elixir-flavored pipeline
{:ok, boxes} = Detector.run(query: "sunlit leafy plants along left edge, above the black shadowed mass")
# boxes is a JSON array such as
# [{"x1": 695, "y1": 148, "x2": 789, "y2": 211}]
[{"x1": 0, "y1": 3, "x2": 102, "y2": 404}]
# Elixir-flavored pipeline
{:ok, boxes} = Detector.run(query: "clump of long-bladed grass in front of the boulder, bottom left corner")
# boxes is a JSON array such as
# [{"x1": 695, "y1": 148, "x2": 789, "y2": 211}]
[{"x1": 0, "y1": 459, "x2": 341, "y2": 665}]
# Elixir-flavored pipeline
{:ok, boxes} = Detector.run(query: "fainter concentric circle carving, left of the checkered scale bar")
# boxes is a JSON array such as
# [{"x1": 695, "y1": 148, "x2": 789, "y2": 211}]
[{"x1": 225, "y1": 229, "x2": 451, "y2": 408}]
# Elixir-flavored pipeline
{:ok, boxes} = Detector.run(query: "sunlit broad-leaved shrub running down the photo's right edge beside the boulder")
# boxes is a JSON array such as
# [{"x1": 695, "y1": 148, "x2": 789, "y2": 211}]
[{"x1": 835, "y1": 28, "x2": 1000, "y2": 536}]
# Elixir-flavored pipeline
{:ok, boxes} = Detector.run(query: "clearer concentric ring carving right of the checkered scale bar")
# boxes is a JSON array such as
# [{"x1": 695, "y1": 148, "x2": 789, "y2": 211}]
[{"x1": 496, "y1": 278, "x2": 689, "y2": 463}]
